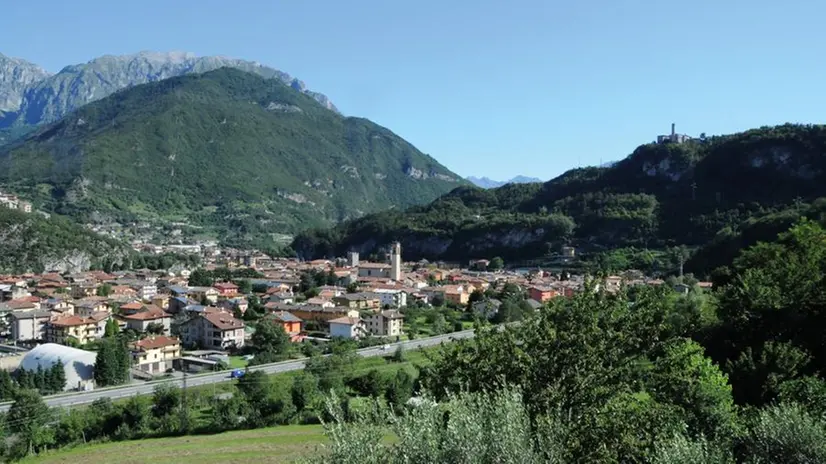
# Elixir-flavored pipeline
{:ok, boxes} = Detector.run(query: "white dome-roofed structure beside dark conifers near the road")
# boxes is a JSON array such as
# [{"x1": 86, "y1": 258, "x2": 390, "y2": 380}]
[{"x1": 20, "y1": 343, "x2": 97, "y2": 390}]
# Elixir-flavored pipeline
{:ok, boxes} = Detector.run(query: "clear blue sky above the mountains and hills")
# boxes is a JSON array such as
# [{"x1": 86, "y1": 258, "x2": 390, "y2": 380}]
[{"x1": 0, "y1": 0, "x2": 826, "y2": 179}]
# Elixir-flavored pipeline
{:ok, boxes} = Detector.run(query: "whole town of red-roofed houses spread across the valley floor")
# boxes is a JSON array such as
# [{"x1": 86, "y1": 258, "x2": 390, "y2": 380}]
[{"x1": 0, "y1": 244, "x2": 710, "y2": 374}]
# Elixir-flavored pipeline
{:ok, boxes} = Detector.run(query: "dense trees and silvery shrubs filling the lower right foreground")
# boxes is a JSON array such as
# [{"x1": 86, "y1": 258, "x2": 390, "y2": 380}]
[{"x1": 308, "y1": 220, "x2": 826, "y2": 463}]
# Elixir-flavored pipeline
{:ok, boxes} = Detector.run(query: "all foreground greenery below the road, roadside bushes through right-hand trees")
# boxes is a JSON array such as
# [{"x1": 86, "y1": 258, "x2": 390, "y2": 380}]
[{"x1": 5, "y1": 219, "x2": 826, "y2": 464}]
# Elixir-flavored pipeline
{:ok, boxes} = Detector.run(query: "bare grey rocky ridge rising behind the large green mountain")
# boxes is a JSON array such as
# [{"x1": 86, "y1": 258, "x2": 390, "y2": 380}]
[{"x1": 0, "y1": 51, "x2": 338, "y2": 138}]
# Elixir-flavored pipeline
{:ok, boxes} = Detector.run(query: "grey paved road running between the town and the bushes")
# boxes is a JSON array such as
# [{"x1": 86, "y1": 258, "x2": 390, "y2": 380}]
[{"x1": 0, "y1": 330, "x2": 473, "y2": 412}]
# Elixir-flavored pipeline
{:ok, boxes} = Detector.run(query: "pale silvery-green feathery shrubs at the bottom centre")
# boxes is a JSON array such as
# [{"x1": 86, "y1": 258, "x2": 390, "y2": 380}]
[{"x1": 310, "y1": 391, "x2": 565, "y2": 464}]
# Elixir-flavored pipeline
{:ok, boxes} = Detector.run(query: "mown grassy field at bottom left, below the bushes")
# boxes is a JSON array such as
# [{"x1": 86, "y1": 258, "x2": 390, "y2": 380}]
[{"x1": 28, "y1": 425, "x2": 326, "y2": 464}]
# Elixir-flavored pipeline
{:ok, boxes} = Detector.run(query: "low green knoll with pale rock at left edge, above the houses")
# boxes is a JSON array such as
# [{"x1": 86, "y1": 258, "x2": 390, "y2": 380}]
[{"x1": 0, "y1": 207, "x2": 130, "y2": 273}]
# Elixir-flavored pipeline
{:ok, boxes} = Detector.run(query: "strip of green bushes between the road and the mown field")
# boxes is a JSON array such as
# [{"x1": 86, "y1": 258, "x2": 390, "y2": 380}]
[{"x1": 0, "y1": 344, "x2": 428, "y2": 461}]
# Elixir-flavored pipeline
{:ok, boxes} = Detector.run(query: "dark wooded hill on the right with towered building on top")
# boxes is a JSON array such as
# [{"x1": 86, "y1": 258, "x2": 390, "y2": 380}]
[{"x1": 293, "y1": 124, "x2": 826, "y2": 270}]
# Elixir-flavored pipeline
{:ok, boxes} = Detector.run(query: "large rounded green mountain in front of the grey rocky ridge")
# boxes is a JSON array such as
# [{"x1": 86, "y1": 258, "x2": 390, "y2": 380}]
[{"x1": 0, "y1": 68, "x2": 465, "y2": 248}]
